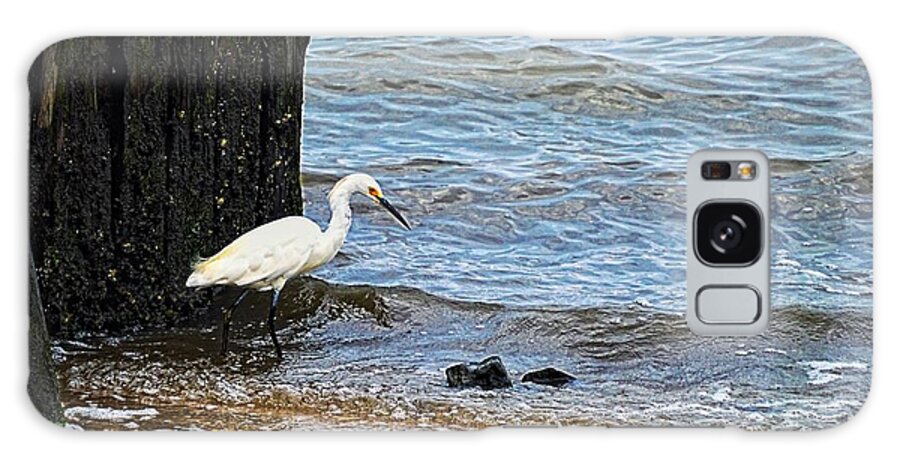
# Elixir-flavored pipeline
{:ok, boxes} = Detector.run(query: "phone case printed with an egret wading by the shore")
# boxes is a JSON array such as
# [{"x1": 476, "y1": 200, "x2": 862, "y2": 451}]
[{"x1": 28, "y1": 37, "x2": 872, "y2": 430}]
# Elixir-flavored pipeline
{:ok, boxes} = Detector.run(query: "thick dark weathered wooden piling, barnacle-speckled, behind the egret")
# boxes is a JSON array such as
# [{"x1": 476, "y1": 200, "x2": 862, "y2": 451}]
[{"x1": 29, "y1": 37, "x2": 308, "y2": 333}]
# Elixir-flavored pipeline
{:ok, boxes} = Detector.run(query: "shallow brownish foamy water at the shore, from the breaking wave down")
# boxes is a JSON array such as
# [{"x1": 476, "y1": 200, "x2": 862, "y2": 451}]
[{"x1": 54, "y1": 279, "x2": 871, "y2": 429}]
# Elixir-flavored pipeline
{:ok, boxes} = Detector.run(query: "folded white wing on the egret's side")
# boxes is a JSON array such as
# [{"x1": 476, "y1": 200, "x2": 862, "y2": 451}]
[{"x1": 187, "y1": 216, "x2": 322, "y2": 286}]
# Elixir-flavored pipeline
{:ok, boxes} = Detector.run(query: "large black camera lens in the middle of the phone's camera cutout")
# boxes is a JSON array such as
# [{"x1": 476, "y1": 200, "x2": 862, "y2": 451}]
[{"x1": 694, "y1": 202, "x2": 763, "y2": 266}]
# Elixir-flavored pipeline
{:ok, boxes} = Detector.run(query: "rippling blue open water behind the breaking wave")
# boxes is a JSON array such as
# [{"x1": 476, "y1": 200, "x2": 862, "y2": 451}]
[{"x1": 303, "y1": 38, "x2": 872, "y2": 312}]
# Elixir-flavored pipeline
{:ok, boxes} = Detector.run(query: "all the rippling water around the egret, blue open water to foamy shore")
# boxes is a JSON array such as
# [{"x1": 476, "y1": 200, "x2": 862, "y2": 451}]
[{"x1": 56, "y1": 38, "x2": 872, "y2": 429}]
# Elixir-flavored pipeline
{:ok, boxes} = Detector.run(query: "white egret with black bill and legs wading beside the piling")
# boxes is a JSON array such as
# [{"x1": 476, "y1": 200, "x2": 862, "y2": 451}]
[{"x1": 186, "y1": 174, "x2": 410, "y2": 358}]
